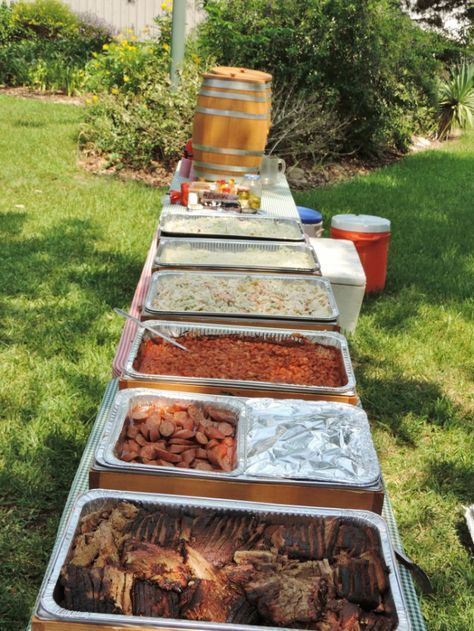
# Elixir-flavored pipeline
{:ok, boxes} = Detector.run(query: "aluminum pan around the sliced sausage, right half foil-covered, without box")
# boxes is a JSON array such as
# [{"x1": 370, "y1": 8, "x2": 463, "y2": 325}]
[{"x1": 95, "y1": 388, "x2": 381, "y2": 489}]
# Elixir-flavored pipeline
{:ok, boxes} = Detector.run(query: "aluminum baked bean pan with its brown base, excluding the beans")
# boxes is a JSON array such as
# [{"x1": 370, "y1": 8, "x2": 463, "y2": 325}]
[{"x1": 120, "y1": 320, "x2": 358, "y2": 403}]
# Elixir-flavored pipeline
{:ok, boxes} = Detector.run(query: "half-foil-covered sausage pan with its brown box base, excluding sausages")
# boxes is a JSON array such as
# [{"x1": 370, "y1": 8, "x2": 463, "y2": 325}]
[{"x1": 89, "y1": 388, "x2": 384, "y2": 513}]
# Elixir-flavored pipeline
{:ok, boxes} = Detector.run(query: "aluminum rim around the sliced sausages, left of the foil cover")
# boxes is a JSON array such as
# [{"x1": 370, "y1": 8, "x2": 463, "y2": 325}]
[{"x1": 95, "y1": 388, "x2": 248, "y2": 480}]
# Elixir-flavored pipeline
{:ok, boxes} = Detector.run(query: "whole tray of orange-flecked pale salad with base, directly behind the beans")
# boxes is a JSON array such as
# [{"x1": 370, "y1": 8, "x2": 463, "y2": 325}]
[{"x1": 142, "y1": 270, "x2": 339, "y2": 330}]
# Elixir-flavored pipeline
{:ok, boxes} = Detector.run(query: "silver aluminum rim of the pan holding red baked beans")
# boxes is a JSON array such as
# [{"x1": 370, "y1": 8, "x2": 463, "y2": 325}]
[{"x1": 123, "y1": 320, "x2": 356, "y2": 395}]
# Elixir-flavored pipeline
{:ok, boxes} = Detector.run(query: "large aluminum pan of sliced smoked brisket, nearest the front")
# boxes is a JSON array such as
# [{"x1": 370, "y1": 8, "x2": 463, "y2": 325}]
[{"x1": 32, "y1": 490, "x2": 412, "y2": 631}]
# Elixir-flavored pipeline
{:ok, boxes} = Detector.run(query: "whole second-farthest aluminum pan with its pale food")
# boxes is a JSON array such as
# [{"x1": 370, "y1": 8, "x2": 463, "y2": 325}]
[{"x1": 154, "y1": 237, "x2": 321, "y2": 274}]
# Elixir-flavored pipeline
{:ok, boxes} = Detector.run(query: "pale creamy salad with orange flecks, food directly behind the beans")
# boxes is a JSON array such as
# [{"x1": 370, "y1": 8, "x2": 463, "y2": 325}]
[{"x1": 151, "y1": 274, "x2": 331, "y2": 318}]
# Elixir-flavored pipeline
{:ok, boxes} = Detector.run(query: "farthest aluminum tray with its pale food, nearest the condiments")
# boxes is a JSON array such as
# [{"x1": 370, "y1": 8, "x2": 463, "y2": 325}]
[{"x1": 160, "y1": 211, "x2": 304, "y2": 241}]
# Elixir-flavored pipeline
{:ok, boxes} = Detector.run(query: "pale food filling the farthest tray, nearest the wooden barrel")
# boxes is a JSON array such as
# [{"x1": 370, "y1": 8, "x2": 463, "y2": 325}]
[{"x1": 162, "y1": 216, "x2": 301, "y2": 240}]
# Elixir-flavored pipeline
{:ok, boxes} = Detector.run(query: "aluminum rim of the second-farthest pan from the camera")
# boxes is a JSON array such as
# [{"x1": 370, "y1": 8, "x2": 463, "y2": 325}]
[{"x1": 154, "y1": 237, "x2": 321, "y2": 274}]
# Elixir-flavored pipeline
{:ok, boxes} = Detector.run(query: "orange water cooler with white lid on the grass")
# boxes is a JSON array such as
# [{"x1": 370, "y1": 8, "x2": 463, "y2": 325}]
[{"x1": 331, "y1": 214, "x2": 390, "y2": 294}]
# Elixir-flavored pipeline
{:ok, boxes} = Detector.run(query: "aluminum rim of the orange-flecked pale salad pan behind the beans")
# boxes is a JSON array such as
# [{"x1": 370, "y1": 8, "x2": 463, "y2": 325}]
[{"x1": 144, "y1": 270, "x2": 339, "y2": 325}]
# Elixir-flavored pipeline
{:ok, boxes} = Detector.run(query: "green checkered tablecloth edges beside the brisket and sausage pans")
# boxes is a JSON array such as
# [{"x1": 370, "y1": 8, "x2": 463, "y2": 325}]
[{"x1": 28, "y1": 379, "x2": 426, "y2": 631}]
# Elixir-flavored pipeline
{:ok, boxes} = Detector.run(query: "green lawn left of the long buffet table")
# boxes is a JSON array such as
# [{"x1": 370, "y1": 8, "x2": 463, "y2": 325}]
[{"x1": 0, "y1": 97, "x2": 162, "y2": 631}]
